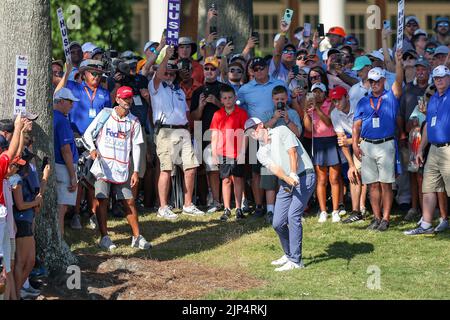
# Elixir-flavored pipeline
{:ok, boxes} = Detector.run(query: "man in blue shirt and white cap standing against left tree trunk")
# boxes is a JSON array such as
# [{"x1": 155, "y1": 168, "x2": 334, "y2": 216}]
[{"x1": 53, "y1": 88, "x2": 80, "y2": 236}]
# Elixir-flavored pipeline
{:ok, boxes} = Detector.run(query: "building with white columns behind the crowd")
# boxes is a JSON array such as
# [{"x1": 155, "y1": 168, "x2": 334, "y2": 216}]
[{"x1": 132, "y1": 0, "x2": 450, "y2": 52}]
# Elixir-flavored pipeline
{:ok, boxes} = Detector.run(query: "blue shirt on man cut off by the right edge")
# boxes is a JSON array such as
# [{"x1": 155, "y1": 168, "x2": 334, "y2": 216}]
[{"x1": 427, "y1": 87, "x2": 450, "y2": 144}]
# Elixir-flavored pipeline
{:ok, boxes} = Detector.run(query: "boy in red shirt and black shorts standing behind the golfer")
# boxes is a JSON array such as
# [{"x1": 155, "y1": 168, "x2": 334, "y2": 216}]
[{"x1": 210, "y1": 85, "x2": 248, "y2": 221}]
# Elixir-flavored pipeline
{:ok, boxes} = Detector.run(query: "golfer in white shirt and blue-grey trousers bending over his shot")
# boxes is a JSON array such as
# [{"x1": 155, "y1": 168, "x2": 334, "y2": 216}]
[{"x1": 244, "y1": 118, "x2": 316, "y2": 271}]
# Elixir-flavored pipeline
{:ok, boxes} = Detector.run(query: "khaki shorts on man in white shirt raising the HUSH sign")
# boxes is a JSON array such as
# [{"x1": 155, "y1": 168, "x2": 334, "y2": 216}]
[{"x1": 156, "y1": 128, "x2": 199, "y2": 171}]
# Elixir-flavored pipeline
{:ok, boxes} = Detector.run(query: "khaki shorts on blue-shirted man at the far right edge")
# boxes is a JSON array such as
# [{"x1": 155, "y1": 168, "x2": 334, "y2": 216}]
[{"x1": 422, "y1": 145, "x2": 450, "y2": 197}]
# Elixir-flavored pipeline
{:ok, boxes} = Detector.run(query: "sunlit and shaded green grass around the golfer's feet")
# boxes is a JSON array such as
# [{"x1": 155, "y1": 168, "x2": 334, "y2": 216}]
[{"x1": 67, "y1": 210, "x2": 450, "y2": 299}]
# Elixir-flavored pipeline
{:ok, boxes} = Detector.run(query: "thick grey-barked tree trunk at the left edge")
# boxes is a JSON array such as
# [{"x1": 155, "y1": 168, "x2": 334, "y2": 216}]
[{"x1": 0, "y1": 0, "x2": 76, "y2": 271}]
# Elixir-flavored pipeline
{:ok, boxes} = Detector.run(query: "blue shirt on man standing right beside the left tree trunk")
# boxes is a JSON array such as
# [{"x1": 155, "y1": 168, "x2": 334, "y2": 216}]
[{"x1": 53, "y1": 110, "x2": 78, "y2": 165}]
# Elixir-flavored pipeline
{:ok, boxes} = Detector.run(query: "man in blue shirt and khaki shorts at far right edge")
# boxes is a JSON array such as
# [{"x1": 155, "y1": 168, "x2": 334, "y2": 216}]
[{"x1": 405, "y1": 65, "x2": 450, "y2": 235}]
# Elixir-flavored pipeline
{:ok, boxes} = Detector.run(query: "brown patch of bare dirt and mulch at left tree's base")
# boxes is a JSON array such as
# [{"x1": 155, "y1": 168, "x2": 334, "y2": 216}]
[{"x1": 37, "y1": 255, "x2": 263, "y2": 300}]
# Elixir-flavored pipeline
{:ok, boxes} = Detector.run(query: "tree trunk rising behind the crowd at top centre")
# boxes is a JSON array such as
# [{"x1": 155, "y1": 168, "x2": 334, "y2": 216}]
[{"x1": 198, "y1": 0, "x2": 253, "y2": 52}]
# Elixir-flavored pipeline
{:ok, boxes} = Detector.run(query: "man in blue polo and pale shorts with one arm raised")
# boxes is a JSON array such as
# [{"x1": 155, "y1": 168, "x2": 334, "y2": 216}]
[{"x1": 352, "y1": 50, "x2": 403, "y2": 231}]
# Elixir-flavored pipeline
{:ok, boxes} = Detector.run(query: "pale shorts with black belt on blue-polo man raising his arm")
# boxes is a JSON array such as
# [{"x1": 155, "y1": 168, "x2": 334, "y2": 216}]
[{"x1": 361, "y1": 140, "x2": 395, "y2": 184}]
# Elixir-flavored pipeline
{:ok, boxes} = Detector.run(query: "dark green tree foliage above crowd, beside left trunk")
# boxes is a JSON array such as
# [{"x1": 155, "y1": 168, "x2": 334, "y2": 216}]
[{"x1": 51, "y1": 0, "x2": 135, "y2": 59}]
